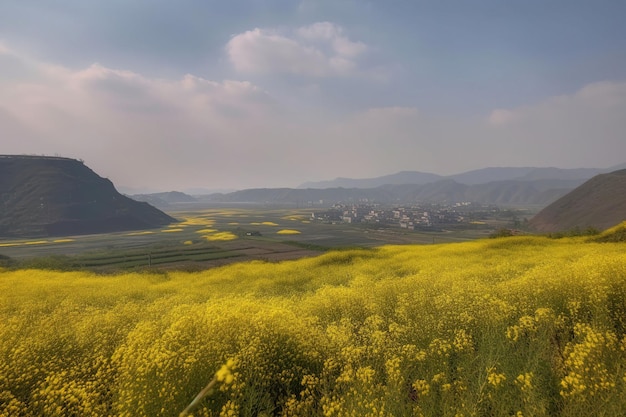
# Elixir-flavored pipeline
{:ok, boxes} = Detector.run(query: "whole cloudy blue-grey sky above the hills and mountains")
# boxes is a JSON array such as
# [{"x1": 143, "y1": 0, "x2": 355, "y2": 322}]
[{"x1": 0, "y1": 0, "x2": 626, "y2": 191}]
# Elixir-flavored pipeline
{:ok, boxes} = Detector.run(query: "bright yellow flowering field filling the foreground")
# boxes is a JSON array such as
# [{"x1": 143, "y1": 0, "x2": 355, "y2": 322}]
[{"x1": 0, "y1": 218, "x2": 626, "y2": 416}]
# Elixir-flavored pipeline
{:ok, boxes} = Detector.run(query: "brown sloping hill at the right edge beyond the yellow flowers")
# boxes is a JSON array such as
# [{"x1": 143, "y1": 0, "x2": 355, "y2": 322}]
[{"x1": 530, "y1": 169, "x2": 626, "y2": 232}]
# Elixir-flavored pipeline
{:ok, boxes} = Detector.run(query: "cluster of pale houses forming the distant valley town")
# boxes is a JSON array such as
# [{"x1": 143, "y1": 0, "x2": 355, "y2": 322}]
[{"x1": 311, "y1": 202, "x2": 497, "y2": 230}]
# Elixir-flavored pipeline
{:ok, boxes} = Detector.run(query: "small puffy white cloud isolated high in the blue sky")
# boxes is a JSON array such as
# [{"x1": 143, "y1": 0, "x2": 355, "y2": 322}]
[{"x1": 226, "y1": 22, "x2": 368, "y2": 77}]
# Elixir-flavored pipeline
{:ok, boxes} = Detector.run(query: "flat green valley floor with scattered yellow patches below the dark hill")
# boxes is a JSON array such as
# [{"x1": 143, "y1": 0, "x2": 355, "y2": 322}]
[{"x1": 0, "y1": 207, "x2": 489, "y2": 272}]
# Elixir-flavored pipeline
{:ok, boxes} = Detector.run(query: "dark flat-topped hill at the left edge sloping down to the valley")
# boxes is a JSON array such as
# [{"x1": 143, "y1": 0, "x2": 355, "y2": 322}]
[{"x1": 0, "y1": 155, "x2": 176, "y2": 237}]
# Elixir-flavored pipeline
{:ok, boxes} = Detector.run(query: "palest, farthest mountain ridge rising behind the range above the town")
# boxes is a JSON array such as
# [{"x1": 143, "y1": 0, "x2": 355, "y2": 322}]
[{"x1": 298, "y1": 171, "x2": 444, "y2": 188}]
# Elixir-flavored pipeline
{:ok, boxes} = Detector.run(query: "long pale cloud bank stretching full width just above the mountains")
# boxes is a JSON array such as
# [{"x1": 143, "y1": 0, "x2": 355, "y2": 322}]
[{"x1": 0, "y1": 41, "x2": 626, "y2": 190}]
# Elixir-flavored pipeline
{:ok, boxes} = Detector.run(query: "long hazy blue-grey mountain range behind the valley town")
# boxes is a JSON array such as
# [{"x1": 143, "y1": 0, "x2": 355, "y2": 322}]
[{"x1": 190, "y1": 164, "x2": 626, "y2": 207}]
